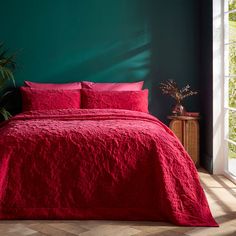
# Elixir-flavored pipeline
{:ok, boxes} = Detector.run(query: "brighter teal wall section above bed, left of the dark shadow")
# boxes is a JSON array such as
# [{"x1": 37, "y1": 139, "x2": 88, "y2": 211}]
[{"x1": 0, "y1": 0, "x2": 150, "y2": 85}]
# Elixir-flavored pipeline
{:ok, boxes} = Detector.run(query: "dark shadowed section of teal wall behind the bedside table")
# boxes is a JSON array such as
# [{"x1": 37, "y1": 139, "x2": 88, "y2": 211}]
[{"x1": 149, "y1": 0, "x2": 200, "y2": 123}]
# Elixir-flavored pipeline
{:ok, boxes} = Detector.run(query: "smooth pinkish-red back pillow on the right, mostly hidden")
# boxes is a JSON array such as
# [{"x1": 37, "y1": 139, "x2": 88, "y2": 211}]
[{"x1": 81, "y1": 81, "x2": 143, "y2": 91}]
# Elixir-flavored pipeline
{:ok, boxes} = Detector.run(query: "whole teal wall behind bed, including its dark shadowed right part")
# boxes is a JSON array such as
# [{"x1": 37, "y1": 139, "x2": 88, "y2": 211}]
[{"x1": 0, "y1": 0, "x2": 199, "y2": 121}]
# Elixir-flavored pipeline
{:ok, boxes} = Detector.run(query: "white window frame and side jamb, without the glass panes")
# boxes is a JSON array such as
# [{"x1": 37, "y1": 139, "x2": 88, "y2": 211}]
[{"x1": 213, "y1": 0, "x2": 236, "y2": 183}]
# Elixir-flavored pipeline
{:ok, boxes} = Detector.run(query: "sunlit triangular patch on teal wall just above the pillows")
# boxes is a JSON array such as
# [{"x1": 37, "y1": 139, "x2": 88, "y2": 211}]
[{"x1": 47, "y1": 31, "x2": 150, "y2": 82}]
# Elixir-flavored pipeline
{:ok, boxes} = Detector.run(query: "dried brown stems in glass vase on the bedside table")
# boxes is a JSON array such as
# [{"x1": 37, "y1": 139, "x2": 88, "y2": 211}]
[{"x1": 160, "y1": 80, "x2": 197, "y2": 115}]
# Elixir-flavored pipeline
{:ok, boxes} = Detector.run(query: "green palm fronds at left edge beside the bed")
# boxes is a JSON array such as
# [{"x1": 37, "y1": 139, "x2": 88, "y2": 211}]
[{"x1": 0, "y1": 43, "x2": 16, "y2": 120}]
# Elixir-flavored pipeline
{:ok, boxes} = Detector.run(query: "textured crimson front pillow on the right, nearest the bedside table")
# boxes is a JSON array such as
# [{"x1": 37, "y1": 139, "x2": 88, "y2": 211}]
[{"x1": 81, "y1": 89, "x2": 148, "y2": 112}]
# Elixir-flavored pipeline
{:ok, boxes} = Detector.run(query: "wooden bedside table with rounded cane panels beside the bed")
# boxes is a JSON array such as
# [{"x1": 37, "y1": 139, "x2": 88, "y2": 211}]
[{"x1": 168, "y1": 116, "x2": 199, "y2": 166}]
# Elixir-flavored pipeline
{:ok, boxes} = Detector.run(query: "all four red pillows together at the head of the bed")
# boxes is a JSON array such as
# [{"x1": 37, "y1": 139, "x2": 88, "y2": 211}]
[{"x1": 20, "y1": 81, "x2": 148, "y2": 112}]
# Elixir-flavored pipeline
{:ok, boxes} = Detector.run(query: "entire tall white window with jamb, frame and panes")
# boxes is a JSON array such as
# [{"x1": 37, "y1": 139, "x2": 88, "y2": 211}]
[{"x1": 213, "y1": 0, "x2": 236, "y2": 183}]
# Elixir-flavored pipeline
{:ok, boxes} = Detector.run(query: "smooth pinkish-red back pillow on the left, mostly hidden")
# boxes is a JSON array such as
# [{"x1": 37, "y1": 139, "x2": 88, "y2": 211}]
[{"x1": 24, "y1": 81, "x2": 82, "y2": 89}]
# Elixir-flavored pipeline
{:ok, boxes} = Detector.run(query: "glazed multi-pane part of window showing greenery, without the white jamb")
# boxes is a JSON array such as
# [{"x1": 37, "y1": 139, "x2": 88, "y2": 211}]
[{"x1": 224, "y1": 0, "x2": 236, "y2": 177}]
